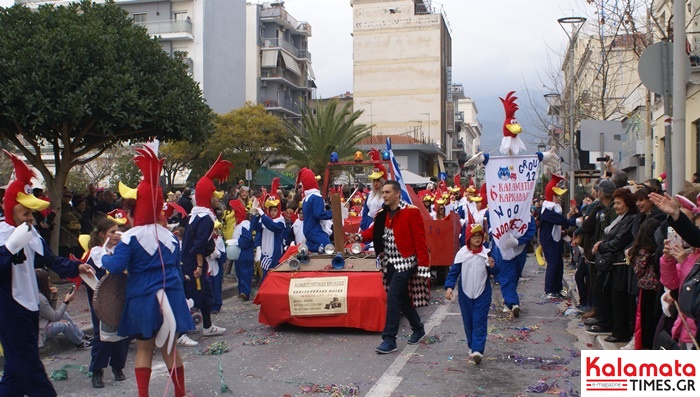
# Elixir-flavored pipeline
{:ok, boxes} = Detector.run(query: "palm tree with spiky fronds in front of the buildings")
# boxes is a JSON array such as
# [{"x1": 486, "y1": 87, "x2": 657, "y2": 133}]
[{"x1": 282, "y1": 100, "x2": 370, "y2": 175}]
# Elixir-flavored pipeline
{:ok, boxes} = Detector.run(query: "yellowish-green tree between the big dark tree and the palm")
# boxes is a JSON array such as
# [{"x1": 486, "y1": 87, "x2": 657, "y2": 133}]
[{"x1": 190, "y1": 103, "x2": 284, "y2": 183}]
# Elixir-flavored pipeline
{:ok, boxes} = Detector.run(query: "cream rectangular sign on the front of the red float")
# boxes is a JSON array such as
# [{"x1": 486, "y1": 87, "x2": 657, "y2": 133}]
[{"x1": 289, "y1": 276, "x2": 348, "y2": 316}]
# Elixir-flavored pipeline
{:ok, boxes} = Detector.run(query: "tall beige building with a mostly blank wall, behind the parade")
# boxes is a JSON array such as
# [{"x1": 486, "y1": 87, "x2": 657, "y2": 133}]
[{"x1": 351, "y1": 0, "x2": 456, "y2": 174}]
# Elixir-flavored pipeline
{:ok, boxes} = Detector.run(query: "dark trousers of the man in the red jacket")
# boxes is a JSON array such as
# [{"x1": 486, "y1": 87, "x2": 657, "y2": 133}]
[{"x1": 382, "y1": 266, "x2": 423, "y2": 343}]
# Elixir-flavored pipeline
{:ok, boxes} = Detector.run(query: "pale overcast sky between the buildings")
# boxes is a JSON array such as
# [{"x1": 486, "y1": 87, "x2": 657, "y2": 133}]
[{"x1": 0, "y1": 0, "x2": 586, "y2": 146}]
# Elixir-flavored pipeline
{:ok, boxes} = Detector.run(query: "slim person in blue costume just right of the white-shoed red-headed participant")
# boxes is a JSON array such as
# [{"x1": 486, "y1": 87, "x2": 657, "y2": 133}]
[{"x1": 229, "y1": 200, "x2": 255, "y2": 301}]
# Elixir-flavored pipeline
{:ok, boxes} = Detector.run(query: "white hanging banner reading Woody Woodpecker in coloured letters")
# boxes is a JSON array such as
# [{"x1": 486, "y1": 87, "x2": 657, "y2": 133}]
[{"x1": 485, "y1": 156, "x2": 539, "y2": 260}]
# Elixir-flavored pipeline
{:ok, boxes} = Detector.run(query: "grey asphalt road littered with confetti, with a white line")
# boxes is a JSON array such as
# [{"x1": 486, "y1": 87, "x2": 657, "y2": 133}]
[{"x1": 31, "y1": 257, "x2": 592, "y2": 397}]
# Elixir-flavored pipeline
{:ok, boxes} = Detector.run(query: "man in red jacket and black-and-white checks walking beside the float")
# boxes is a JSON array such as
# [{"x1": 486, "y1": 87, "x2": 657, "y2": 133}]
[{"x1": 355, "y1": 181, "x2": 430, "y2": 354}]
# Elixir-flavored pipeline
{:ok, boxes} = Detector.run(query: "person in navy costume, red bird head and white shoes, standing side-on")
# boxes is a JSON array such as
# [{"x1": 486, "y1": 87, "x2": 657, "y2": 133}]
[{"x1": 182, "y1": 155, "x2": 233, "y2": 336}]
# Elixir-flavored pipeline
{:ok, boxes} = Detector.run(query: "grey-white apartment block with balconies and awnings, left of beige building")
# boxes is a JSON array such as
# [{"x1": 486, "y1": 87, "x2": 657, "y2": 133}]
[{"x1": 245, "y1": 3, "x2": 316, "y2": 119}]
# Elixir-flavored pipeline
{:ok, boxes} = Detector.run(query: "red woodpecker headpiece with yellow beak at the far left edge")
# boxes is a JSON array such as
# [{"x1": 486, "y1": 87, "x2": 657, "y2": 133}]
[{"x1": 3, "y1": 149, "x2": 51, "y2": 226}]
